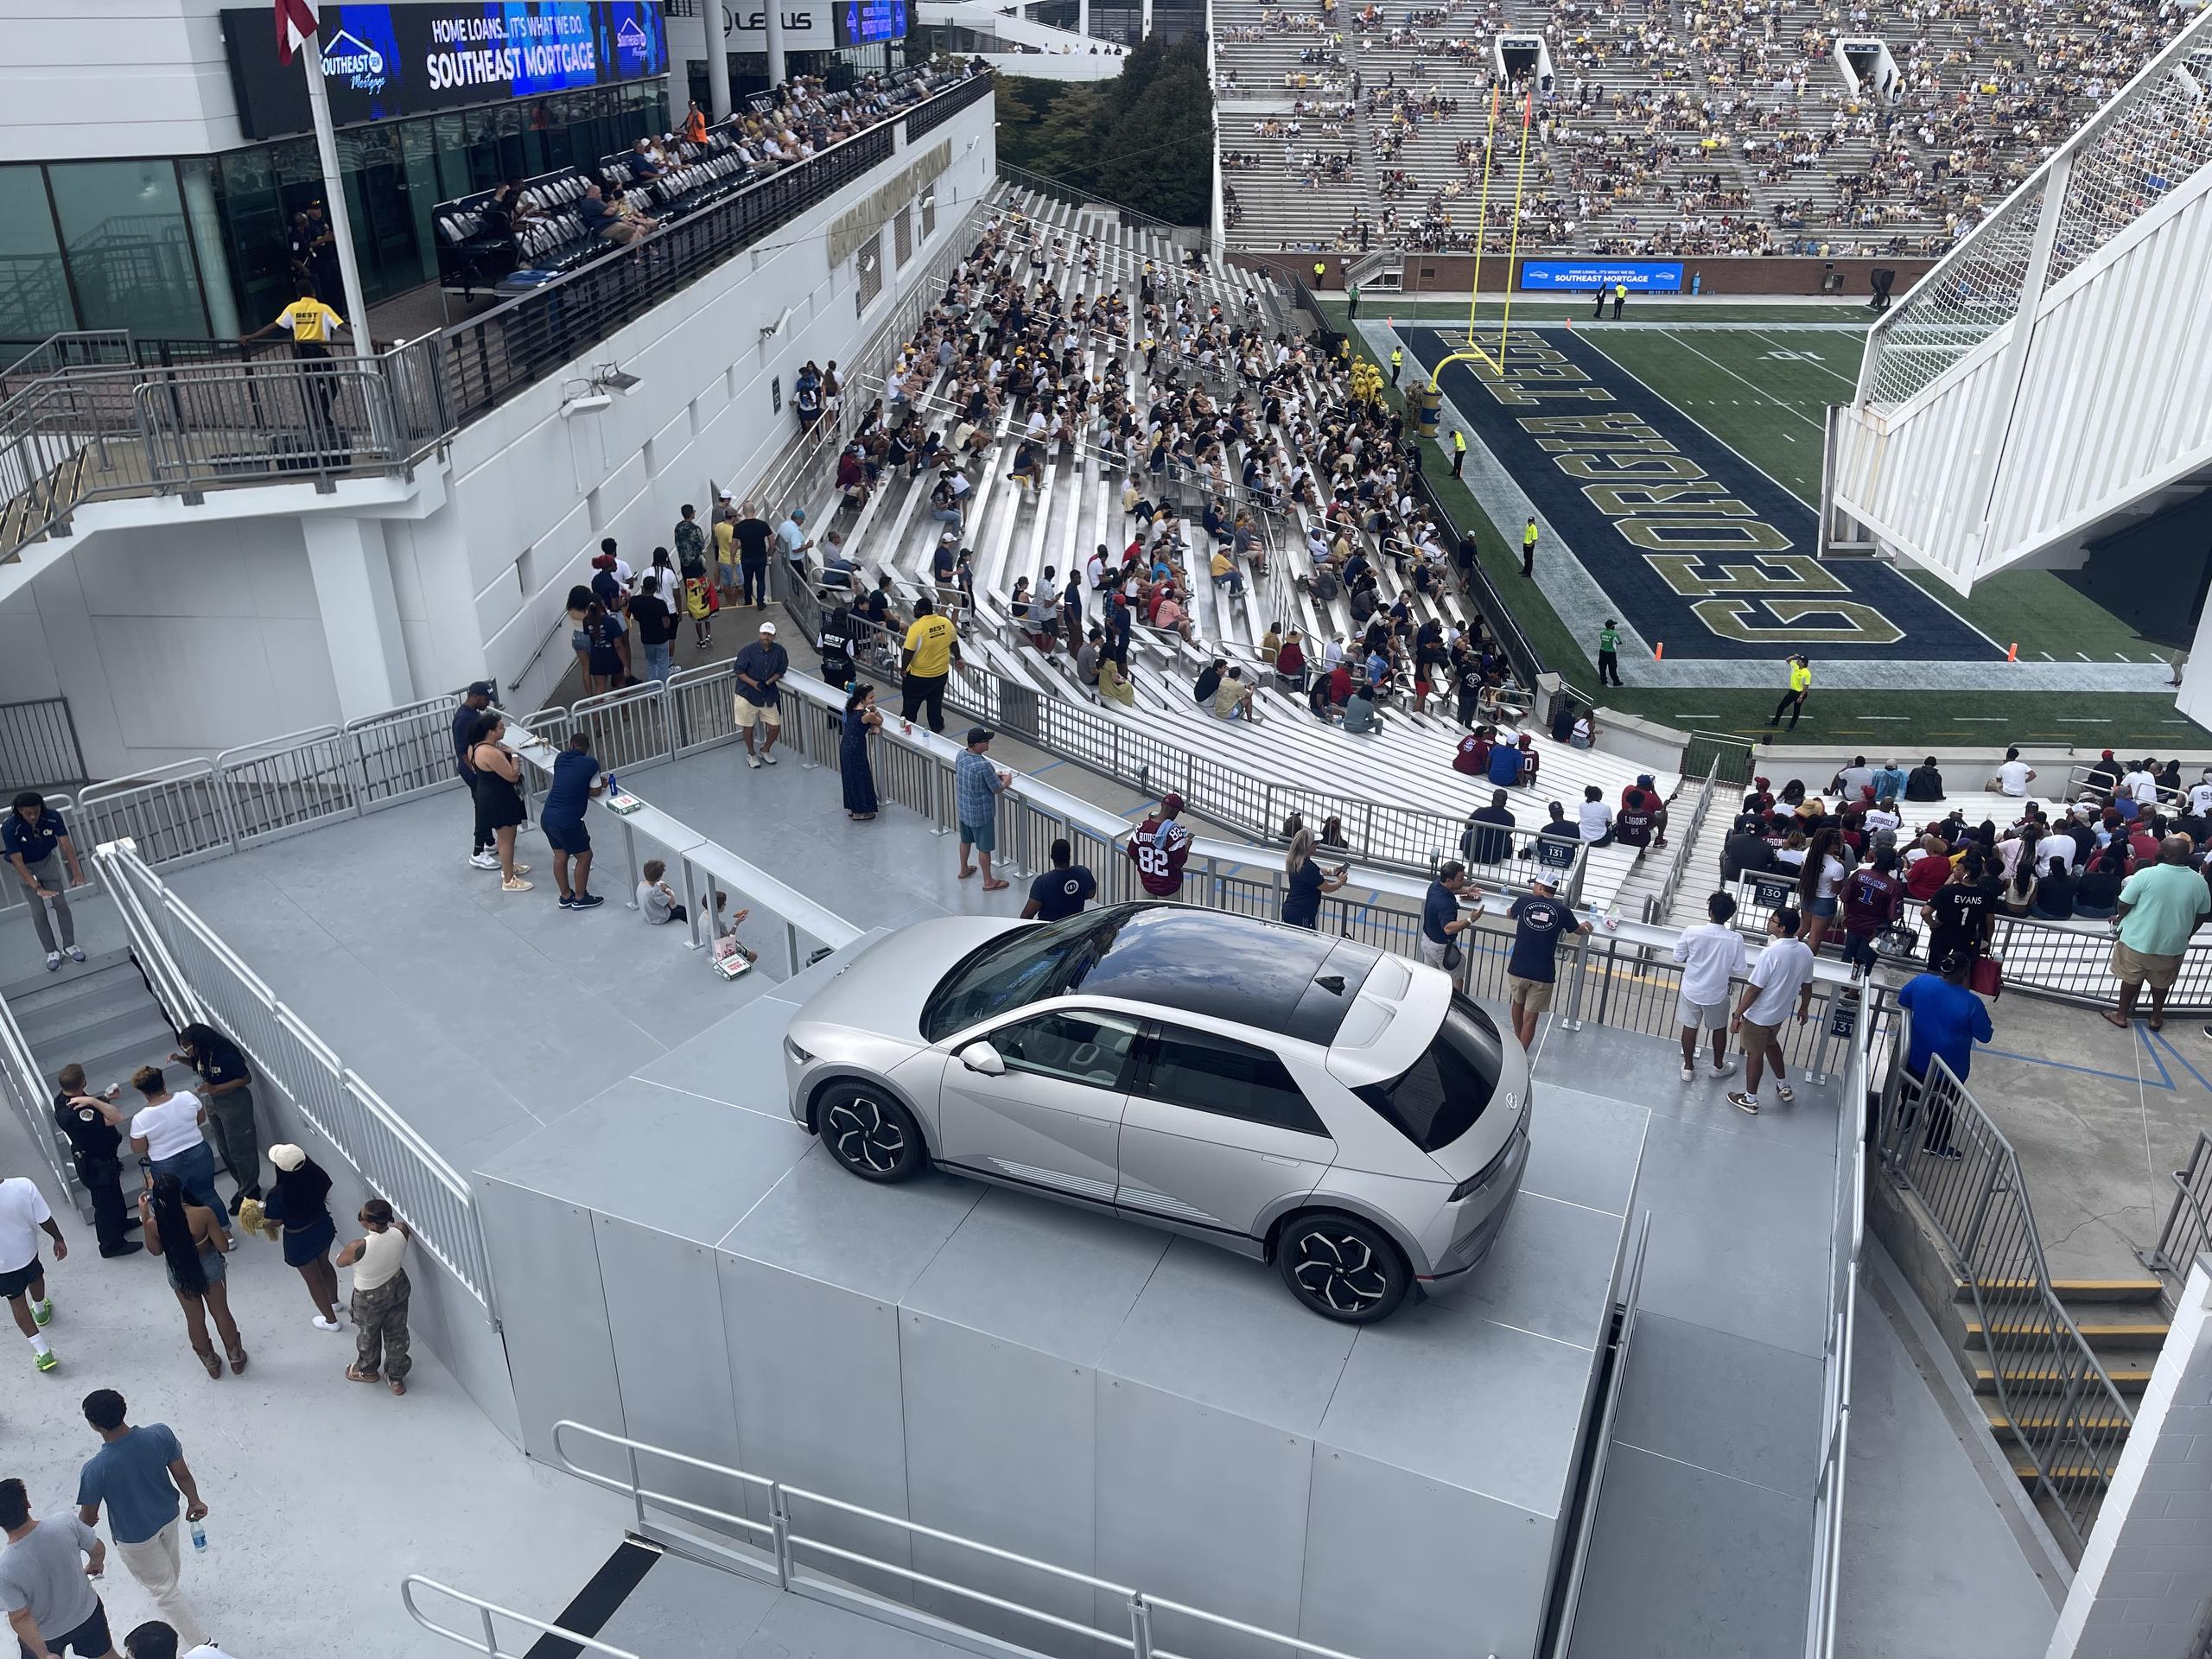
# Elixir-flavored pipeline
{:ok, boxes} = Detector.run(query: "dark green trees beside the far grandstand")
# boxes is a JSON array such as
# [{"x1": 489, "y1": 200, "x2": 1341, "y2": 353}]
[{"x1": 998, "y1": 33, "x2": 1214, "y2": 226}]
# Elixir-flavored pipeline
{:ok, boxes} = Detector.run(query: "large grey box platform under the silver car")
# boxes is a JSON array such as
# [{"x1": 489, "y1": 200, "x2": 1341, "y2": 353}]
[{"x1": 478, "y1": 960, "x2": 1643, "y2": 1659}]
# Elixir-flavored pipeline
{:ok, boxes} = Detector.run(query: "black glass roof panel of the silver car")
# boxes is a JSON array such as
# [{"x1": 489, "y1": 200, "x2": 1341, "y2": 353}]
[{"x1": 1066, "y1": 905, "x2": 1380, "y2": 1048}]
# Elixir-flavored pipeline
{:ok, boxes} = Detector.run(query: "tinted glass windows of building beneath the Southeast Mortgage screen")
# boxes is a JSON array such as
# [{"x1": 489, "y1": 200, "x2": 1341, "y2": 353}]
[{"x1": 0, "y1": 78, "x2": 671, "y2": 340}]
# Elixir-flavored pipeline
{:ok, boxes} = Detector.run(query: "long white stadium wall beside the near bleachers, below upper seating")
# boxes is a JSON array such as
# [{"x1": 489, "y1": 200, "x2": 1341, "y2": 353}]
[{"x1": 0, "y1": 98, "x2": 998, "y2": 777}]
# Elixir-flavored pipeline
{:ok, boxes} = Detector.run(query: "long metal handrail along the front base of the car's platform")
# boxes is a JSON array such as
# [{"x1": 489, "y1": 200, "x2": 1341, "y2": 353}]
[{"x1": 543, "y1": 1418, "x2": 1354, "y2": 1659}]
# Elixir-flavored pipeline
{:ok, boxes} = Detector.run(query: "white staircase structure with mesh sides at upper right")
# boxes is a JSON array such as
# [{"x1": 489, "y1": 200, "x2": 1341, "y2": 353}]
[{"x1": 1821, "y1": 11, "x2": 2212, "y2": 593}]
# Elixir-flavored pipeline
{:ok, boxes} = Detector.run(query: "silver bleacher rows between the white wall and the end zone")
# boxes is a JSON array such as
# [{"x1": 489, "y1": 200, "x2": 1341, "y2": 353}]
[{"x1": 757, "y1": 188, "x2": 1679, "y2": 920}]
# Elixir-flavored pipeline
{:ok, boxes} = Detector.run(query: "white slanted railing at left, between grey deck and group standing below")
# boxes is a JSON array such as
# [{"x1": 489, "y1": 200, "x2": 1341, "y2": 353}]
[{"x1": 93, "y1": 838, "x2": 493, "y2": 1316}]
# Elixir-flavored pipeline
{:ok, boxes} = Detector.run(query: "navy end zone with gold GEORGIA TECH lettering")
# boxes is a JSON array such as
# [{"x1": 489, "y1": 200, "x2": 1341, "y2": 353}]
[{"x1": 1398, "y1": 327, "x2": 2002, "y2": 661}]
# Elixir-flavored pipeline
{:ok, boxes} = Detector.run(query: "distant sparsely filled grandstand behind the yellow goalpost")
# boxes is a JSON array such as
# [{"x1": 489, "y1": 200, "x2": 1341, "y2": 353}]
[{"x1": 1214, "y1": 0, "x2": 2190, "y2": 257}]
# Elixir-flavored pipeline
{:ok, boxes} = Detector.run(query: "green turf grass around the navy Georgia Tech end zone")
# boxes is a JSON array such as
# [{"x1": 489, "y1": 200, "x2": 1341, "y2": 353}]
[{"x1": 1323, "y1": 301, "x2": 2212, "y2": 754}]
